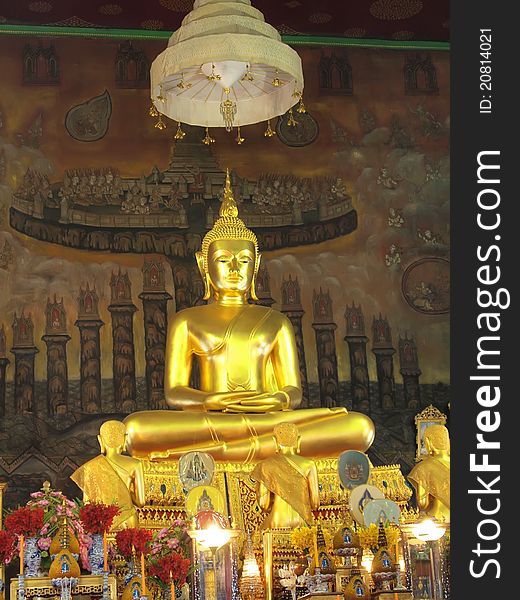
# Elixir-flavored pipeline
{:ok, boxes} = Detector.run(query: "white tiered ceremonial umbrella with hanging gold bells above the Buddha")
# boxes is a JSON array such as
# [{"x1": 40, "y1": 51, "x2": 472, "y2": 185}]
[{"x1": 150, "y1": 0, "x2": 304, "y2": 144}]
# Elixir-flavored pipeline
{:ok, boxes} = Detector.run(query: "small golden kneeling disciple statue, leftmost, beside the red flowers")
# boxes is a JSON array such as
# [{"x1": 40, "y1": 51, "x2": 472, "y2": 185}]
[{"x1": 71, "y1": 421, "x2": 145, "y2": 529}]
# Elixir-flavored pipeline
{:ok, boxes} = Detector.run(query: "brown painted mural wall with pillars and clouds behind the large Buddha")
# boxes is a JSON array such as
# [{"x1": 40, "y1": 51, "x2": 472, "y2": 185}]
[{"x1": 0, "y1": 37, "x2": 450, "y2": 503}]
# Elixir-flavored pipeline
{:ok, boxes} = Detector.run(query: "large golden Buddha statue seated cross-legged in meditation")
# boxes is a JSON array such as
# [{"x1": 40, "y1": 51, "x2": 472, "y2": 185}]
[{"x1": 125, "y1": 173, "x2": 374, "y2": 462}]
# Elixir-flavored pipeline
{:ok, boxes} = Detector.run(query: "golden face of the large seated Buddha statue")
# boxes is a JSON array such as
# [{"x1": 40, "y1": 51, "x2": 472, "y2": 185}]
[{"x1": 208, "y1": 240, "x2": 256, "y2": 294}]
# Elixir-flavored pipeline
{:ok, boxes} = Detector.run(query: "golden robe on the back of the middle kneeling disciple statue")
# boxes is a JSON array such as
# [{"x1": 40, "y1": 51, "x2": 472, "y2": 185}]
[{"x1": 251, "y1": 454, "x2": 314, "y2": 524}]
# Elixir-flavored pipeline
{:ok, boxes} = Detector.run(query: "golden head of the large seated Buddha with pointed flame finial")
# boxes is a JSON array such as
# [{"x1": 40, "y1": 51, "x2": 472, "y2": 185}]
[{"x1": 196, "y1": 171, "x2": 260, "y2": 300}]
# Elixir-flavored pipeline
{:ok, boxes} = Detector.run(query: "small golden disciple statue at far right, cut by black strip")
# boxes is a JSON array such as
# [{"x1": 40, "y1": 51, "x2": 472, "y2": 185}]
[{"x1": 408, "y1": 425, "x2": 450, "y2": 522}]
